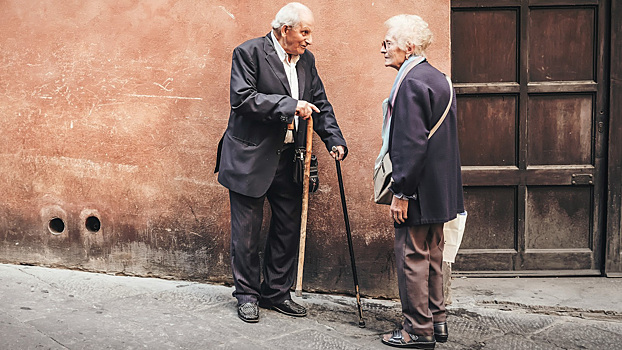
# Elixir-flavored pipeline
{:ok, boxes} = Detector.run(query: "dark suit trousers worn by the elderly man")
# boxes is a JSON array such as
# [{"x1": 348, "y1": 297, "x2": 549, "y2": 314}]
[{"x1": 229, "y1": 146, "x2": 302, "y2": 304}]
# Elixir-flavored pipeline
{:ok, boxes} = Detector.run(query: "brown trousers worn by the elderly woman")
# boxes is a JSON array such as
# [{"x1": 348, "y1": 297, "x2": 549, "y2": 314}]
[{"x1": 395, "y1": 224, "x2": 446, "y2": 336}]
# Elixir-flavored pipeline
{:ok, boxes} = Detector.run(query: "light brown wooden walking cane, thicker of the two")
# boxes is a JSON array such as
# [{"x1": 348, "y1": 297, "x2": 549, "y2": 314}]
[{"x1": 296, "y1": 117, "x2": 313, "y2": 297}]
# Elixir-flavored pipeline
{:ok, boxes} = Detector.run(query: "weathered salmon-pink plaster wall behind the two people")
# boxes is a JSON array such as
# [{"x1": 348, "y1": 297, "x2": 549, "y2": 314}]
[{"x1": 0, "y1": 0, "x2": 450, "y2": 296}]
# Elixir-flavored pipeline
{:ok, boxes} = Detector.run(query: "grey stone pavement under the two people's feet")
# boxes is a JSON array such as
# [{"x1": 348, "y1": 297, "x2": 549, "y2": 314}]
[{"x1": 0, "y1": 264, "x2": 622, "y2": 350}]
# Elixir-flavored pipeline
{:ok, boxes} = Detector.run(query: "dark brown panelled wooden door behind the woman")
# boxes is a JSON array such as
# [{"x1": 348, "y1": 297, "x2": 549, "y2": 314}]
[{"x1": 451, "y1": 0, "x2": 608, "y2": 275}]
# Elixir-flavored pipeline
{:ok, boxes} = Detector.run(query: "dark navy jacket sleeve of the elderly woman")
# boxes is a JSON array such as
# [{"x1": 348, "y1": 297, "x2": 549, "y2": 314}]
[{"x1": 389, "y1": 79, "x2": 432, "y2": 197}]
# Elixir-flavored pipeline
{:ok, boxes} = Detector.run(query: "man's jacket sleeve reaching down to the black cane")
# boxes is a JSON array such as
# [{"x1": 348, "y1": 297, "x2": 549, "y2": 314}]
[{"x1": 310, "y1": 60, "x2": 348, "y2": 154}]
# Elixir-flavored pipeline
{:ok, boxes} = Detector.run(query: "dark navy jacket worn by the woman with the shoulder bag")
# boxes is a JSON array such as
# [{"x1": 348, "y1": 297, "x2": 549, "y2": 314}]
[{"x1": 389, "y1": 61, "x2": 464, "y2": 226}]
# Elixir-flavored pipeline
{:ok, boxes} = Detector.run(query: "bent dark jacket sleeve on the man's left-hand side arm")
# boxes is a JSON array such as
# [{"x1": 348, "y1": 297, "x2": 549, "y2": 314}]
[{"x1": 229, "y1": 47, "x2": 298, "y2": 123}]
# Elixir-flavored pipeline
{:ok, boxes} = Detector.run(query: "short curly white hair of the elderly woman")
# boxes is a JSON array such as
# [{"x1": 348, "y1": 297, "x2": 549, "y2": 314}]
[{"x1": 384, "y1": 15, "x2": 432, "y2": 56}]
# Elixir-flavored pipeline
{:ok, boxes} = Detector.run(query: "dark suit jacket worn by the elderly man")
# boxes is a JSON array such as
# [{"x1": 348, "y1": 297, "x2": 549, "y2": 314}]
[{"x1": 216, "y1": 35, "x2": 346, "y2": 197}]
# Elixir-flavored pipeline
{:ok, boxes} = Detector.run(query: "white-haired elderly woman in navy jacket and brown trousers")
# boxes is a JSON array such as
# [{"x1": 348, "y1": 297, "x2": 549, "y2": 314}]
[{"x1": 379, "y1": 15, "x2": 464, "y2": 349}]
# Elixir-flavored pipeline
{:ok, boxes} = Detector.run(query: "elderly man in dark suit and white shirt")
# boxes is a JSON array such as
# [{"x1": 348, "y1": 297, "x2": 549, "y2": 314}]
[{"x1": 216, "y1": 2, "x2": 347, "y2": 322}]
